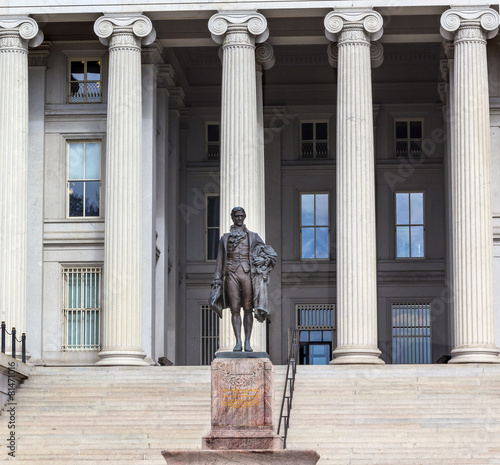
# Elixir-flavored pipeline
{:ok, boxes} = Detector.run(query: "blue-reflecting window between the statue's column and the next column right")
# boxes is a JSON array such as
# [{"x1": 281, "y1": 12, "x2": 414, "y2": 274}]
[{"x1": 300, "y1": 193, "x2": 330, "y2": 259}]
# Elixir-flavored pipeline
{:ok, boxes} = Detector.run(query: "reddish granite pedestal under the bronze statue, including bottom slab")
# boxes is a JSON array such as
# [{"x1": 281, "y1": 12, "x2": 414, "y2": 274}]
[{"x1": 162, "y1": 354, "x2": 319, "y2": 465}]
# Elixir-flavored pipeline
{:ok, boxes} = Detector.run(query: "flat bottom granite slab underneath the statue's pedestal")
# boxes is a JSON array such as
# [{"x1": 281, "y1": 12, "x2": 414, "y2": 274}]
[{"x1": 162, "y1": 450, "x2": 319, "y2": 465}]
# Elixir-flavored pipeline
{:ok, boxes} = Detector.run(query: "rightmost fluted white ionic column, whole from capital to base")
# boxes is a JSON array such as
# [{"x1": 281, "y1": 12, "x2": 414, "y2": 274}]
[{"x1": 441, "y1": 7, "x2": 500, "y2": 363}]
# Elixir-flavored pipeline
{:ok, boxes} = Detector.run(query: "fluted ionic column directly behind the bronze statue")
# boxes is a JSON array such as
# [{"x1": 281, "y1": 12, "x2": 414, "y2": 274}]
[{"x1": 208, "y1": 11, "x2": 268, "y2": 351}]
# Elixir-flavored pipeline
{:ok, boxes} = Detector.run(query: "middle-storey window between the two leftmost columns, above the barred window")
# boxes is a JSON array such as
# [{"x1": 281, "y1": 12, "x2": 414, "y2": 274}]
[{"x1": 67, "y1": 142, "x2": 101, "y2": 218}]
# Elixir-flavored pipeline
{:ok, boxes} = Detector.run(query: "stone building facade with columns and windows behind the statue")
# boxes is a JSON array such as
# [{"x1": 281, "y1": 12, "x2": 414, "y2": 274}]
[{"x1": 0, "y1": 0, "x2": 500, "y2": 365}]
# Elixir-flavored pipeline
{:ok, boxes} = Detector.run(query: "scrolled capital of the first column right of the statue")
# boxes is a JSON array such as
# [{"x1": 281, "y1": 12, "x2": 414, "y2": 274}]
[{"x1": 324, "y1": 8, "x2": 384, "y2": 42}]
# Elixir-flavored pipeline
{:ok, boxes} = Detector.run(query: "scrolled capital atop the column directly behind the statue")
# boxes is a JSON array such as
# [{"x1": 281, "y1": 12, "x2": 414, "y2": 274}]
[{"x1": 208, "y1": 10, "x2": 269, "y2": 44}]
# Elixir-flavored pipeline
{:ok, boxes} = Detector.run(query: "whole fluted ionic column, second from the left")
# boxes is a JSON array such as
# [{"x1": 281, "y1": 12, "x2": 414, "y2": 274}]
[{"x1": 94, "y1": 15, "x2": 155, "y2": 365}]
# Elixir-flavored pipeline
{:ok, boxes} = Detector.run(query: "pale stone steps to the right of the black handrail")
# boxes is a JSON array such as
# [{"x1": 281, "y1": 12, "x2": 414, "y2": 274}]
[{"x1": 287, "y1": 365, "x2": 500, "y2": 465}]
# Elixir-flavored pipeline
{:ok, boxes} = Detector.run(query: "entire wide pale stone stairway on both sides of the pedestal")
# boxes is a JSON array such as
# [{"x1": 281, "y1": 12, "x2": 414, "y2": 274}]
[{"x1": 0, "y1": 365, "x2": 500, "y2": 465}]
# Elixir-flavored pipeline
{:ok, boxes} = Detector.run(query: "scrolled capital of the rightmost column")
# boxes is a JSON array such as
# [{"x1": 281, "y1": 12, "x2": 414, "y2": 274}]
[{"x1": 440, "y1": 6, "x2": 500, "y2": 40}]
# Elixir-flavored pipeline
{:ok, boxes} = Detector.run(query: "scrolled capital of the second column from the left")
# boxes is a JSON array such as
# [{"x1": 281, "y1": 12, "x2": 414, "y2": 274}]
[{"x1": 94, "y1": 13, "x2": 156, "y2": 46}]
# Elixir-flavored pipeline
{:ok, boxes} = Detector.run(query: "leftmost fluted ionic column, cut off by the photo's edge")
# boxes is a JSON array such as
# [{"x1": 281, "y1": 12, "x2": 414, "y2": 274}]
[{"x1": 0, "y1": 16, "x2": 43, "y2": 353}]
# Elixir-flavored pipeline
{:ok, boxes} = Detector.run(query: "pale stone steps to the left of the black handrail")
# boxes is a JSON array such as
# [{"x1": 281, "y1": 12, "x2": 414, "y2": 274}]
[{"x1": 0, "y1": 367, "x2": 285, "y2": 465}]
